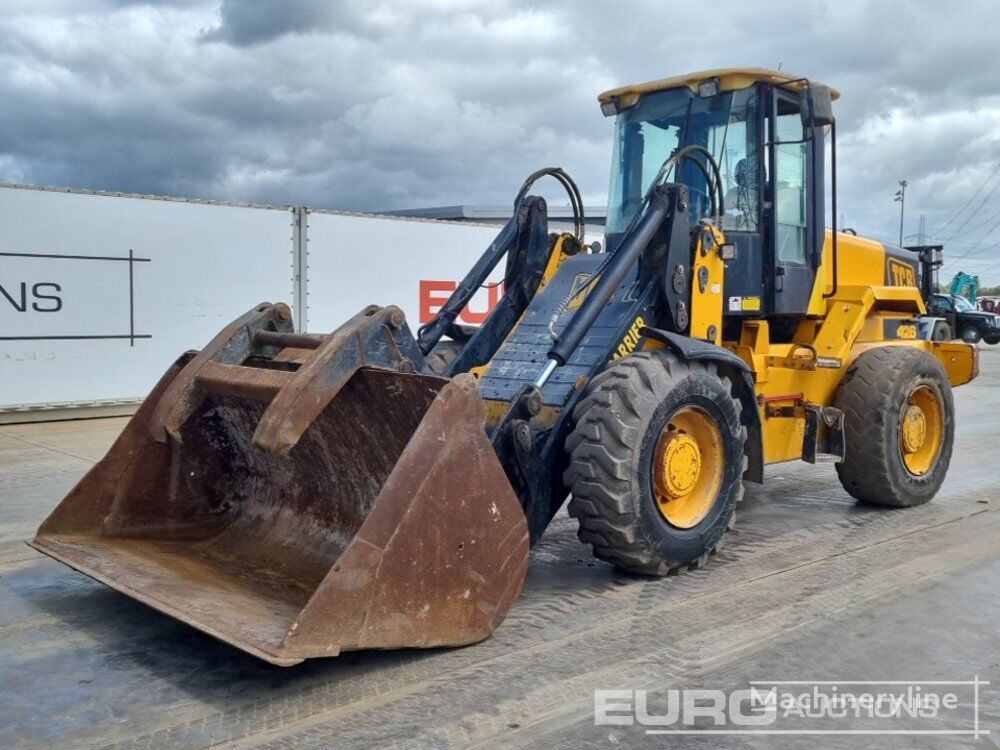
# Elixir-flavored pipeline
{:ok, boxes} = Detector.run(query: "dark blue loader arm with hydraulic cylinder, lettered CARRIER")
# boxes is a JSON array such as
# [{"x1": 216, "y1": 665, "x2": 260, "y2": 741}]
[{"x1": 474, "y1": 183, "x2": 692, "y2": 542}]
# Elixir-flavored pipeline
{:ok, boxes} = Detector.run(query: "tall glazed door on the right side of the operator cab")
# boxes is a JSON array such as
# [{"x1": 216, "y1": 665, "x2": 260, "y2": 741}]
[{"x1": 766, "y1": 89, "x2": 824, "y2": 315}]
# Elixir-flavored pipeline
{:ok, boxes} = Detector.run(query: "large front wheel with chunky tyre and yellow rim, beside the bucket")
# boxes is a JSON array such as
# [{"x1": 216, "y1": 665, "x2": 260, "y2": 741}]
[{"x1": 564, "y1": 349, "x2": 746, "y2": 575}]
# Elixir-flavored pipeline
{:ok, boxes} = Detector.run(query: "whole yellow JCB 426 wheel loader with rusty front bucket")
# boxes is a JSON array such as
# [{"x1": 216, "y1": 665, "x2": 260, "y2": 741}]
[{"x1": 33, "y1": 69, "x2": 978, "y2": 665}]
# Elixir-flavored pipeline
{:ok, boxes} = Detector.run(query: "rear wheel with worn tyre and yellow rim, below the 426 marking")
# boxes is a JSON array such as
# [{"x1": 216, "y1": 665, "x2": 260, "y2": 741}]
[{"x1": 835, "y1": 346, "x2": 955, "y2": 508}]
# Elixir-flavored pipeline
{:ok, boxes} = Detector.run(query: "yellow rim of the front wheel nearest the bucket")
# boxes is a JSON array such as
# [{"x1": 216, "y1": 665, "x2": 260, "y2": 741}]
[{"x1": 653, "y1": 406, "x2": 725, "y2": 529}]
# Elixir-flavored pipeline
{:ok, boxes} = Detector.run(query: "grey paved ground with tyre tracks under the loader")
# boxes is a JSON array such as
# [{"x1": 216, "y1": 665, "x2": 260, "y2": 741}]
[{"x1": 0, "y1": 347, "x2": 1000, "y2": 750}]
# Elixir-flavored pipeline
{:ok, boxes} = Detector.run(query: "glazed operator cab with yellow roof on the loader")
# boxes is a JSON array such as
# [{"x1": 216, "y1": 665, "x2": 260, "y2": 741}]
[{"x1": 599, "y1": 68, "x2": 837, "y2": 322}]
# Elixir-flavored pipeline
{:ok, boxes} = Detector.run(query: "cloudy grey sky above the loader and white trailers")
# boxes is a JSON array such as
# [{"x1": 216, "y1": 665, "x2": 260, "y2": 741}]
[{"x1": 0, "y1": 0, "x2": 1000, "y2": 283}]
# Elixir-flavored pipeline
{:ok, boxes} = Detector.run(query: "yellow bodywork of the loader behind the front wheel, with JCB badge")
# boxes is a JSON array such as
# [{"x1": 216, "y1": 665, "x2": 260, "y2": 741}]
[{"x1": 645, "y1": 229, "x2": 979, "y2": 463}]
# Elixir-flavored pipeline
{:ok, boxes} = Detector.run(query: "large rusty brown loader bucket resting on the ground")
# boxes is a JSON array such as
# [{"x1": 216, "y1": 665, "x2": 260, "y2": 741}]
[{"x1": 31, "y1": 306, "x2": 528, "y2": 665}]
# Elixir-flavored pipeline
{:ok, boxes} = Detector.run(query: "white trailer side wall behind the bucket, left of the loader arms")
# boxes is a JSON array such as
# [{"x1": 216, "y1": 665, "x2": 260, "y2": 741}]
[{"x1": 0, "y1": 185, "x2": 497, "y2": 422}]
